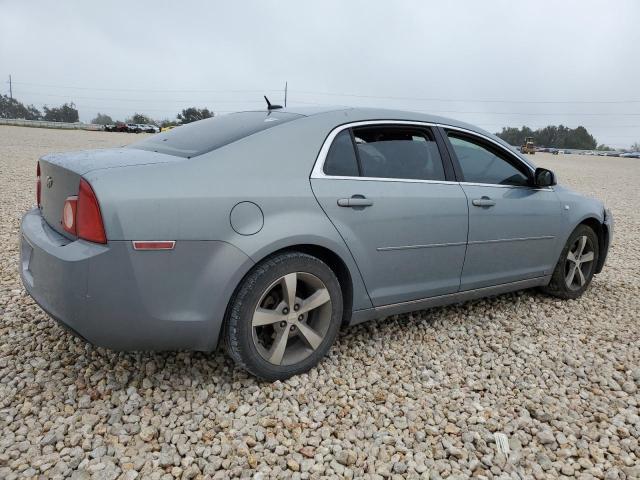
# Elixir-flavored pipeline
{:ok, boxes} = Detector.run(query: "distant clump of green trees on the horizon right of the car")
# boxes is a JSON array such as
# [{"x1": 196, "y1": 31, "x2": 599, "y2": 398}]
[{"x1": 496, "y1": 125, "x2": 609, "y2": 150}]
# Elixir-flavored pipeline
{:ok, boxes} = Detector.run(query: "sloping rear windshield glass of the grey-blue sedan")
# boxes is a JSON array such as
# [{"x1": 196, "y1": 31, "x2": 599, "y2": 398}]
[{"x1": 129, "y1": 111, "x2": 303, "y2": 158}]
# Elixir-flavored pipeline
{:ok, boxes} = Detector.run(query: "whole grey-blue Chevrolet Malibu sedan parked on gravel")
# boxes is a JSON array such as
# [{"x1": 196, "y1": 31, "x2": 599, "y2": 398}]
[{"x1": 20, "y1": 106, "x2": 613, "y2": 380}]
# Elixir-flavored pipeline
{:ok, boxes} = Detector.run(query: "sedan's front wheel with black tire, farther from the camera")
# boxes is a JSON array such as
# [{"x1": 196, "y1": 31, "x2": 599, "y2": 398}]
[{"x1": 542, "y1": 225, "x2": 600, "y2": 300}]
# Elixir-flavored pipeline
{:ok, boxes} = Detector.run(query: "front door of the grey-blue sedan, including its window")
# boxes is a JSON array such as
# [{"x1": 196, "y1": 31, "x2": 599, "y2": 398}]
[{"x1": 447, "y1": 130, "x2": 561, "y2": 290}]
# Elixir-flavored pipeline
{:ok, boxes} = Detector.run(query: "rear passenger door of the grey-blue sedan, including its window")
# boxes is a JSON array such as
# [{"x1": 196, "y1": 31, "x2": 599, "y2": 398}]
[{"x1": 311, "y1": 122, "x2": 468, "y2": 306}]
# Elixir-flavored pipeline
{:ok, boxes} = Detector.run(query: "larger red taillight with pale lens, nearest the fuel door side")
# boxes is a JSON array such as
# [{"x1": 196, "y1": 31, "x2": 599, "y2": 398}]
[{"x1": 62, "y1": 179, "x2": 107, "y2": 243}]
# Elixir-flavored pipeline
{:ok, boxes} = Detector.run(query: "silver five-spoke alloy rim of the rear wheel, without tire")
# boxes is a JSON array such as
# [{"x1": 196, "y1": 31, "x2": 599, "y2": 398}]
[{"x1": 251, "y1": 272, "x2": 332, "y2": 365}]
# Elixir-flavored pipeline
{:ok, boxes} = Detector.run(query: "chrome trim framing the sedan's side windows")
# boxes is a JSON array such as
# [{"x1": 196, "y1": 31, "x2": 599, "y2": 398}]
[{"x1": 310, "y1": 120, "x2": 536, "y2": 190}]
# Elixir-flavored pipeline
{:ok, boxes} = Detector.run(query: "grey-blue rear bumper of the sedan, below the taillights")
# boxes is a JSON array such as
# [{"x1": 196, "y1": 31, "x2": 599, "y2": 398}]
[{"x1": 20, "y1": 209, "x2": 253, "y2": 351}]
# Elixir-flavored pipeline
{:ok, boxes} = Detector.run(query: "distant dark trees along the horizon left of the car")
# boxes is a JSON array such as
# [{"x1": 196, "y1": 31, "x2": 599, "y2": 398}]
[{"x1": 0, "y1": 95, "x2": 214, "y2": 127}]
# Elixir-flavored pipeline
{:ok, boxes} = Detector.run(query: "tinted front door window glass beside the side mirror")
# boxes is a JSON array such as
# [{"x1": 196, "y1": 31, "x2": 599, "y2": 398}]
[{"x1": 447, "y1": 132, "x2": 529, "y2": 186}]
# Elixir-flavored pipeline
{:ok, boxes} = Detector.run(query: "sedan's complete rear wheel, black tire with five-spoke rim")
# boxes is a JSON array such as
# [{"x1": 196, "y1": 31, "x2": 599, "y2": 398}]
[{"x1": 224, "y1": 252, "x2": 343, "y2": 381}]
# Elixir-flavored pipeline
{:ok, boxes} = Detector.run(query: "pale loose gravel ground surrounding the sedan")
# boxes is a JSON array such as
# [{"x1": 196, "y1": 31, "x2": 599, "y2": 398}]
[{"x1": 0, "y1": 127, "x2": 640, "y2": 479}]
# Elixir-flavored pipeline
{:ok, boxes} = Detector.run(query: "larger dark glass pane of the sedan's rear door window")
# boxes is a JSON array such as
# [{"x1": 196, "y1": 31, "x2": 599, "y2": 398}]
[{"x1": 353, "y1": 126, "x2": 445, "y2": 180}]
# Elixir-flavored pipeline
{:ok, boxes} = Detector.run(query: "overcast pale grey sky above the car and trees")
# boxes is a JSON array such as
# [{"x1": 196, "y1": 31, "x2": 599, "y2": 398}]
[{"x1": 0, "y1": 0, "x2": 640, "y2": 147}]
